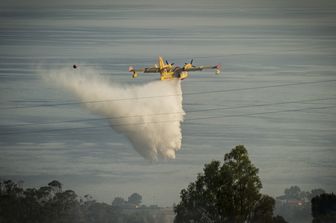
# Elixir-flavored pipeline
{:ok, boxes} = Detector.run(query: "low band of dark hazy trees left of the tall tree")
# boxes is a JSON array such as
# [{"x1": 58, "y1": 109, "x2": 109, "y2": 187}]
[{"x1": 0, "y1": 180, "x2": 167, "y2": 223}]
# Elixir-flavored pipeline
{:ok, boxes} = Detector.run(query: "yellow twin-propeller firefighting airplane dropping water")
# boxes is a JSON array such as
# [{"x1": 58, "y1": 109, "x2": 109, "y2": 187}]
[{"x1": 128, "y1": 57, "x2": 221, "y2": 81}]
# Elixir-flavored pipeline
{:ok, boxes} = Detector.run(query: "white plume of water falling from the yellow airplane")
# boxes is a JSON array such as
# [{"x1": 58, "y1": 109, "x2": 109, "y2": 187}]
[{"x1": 43, "y1": 68, "x2": 185, "y2": 160}]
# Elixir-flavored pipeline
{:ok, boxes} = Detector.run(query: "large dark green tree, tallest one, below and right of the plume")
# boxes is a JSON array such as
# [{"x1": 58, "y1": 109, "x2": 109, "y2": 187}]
[{"x1": 174, "y1": 145, "x2": 284, "y2": 223}]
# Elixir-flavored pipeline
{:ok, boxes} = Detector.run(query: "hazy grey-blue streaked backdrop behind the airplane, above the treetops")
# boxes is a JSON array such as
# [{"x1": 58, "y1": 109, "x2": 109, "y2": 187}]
[{"x1": 0, "y1": 0, "x2": 336, "y2": 205}]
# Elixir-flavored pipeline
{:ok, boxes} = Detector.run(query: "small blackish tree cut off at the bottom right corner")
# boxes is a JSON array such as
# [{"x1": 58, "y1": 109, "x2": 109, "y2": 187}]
[{"x1": 311, "y1": 193, "x2": 336, "y2": 223}]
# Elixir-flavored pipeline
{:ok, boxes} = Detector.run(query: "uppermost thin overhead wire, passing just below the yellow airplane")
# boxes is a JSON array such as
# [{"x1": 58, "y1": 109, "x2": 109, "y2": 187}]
[{"x1": 0, "y1": 80, "x2": 336, "y2": 110}]
